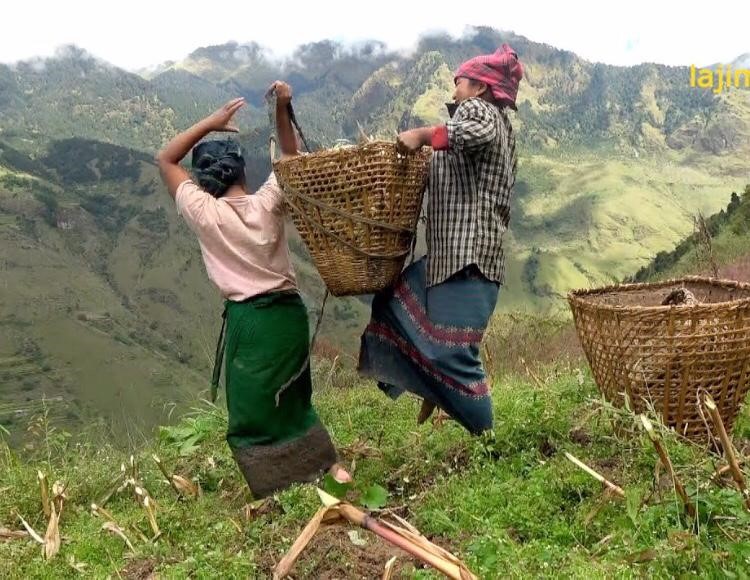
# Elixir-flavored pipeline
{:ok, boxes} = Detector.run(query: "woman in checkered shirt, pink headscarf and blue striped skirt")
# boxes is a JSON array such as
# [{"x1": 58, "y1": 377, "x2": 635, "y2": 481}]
[{"x1": 359, "y1": 44, "x2": 523, "y2": 434}]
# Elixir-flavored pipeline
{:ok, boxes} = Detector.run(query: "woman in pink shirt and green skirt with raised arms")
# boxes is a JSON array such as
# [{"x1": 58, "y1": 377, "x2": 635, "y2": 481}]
[{"x1": 156, "y1": 82, "x2": 351, "y2": 497}]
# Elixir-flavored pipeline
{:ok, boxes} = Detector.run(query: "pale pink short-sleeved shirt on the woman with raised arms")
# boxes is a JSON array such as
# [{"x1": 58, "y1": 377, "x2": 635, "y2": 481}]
[{"x1": 175, "y1": 173, "x2": 297, "y2": 301}]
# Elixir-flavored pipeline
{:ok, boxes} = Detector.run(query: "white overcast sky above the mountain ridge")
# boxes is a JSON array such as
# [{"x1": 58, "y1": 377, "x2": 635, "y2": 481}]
[{"x1": 0, "y1": 0, "x2": 750, "y2": 70}]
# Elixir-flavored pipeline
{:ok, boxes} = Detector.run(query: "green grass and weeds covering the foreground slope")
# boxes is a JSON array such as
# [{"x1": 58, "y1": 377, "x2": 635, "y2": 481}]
[{"x1": 0, "y1": 364, "x2": 750, "y2": 578}]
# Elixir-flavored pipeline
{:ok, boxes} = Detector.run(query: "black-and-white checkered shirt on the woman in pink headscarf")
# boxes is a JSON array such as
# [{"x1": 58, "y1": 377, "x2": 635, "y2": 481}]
[{"x1": 426, "y1": 98, "x2": 517, "y2": 286}]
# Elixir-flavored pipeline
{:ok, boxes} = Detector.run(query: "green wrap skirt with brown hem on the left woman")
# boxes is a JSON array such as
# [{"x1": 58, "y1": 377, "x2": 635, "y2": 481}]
[{"x1": 212, "y1": 291, "x2": 336, "y2": 497}]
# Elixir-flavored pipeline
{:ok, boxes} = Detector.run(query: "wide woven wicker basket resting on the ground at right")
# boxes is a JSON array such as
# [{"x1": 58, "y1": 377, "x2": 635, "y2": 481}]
[{"x1": 568, "y1": 277, "x2": 750, "y2": 441}]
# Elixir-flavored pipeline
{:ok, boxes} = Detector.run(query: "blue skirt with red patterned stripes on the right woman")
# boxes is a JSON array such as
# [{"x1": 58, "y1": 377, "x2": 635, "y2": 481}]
[{"x1": 359, "y1": 258, "x2": 500, "y2": 434}]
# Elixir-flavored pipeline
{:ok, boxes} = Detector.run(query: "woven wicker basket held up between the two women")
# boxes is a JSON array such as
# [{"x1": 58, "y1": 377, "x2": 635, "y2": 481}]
[{"x1": 273, "y1": 141, "x2": 430, "y2": 296}]
